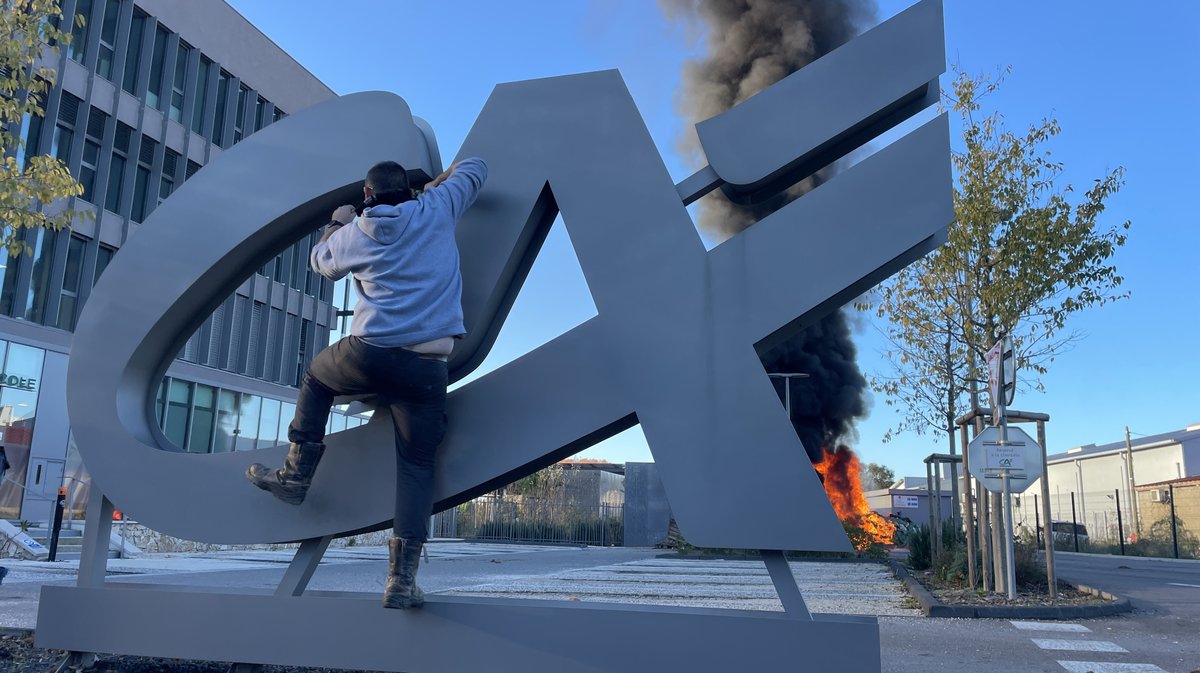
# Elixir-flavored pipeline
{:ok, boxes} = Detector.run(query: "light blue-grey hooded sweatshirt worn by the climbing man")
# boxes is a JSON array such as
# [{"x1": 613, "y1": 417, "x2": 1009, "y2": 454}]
[{"x1": 310, "y1": 157, "x2": 487, "y2": 348}]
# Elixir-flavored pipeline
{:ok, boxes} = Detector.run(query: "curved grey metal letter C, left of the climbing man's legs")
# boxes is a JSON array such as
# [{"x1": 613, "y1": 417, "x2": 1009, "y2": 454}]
[{"x1": 67, "y1": 92, "x2": 436, "y2": 542}]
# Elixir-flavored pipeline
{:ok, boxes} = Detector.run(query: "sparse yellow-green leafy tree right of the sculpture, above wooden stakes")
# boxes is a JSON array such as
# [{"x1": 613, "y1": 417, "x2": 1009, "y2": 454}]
[{"x1": 860, "y1": 70, "x2": 1129, "y2": 452}]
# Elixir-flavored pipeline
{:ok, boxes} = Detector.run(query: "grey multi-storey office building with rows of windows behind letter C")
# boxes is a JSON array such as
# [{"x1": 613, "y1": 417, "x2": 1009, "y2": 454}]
[{"x1": 0, "y1": 0, "x2": 365, "y2": 522}]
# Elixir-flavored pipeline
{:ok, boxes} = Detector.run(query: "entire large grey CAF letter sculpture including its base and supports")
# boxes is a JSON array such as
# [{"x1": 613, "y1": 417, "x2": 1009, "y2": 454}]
[{"x1": 37, "y1": 0, "x2": 953, "y2": 673}]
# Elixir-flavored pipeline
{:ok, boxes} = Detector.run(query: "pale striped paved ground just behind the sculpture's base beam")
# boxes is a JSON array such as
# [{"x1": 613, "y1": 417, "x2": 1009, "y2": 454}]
[{"x1": 0, "y1": 540, "x2": 919, "y2": 629}]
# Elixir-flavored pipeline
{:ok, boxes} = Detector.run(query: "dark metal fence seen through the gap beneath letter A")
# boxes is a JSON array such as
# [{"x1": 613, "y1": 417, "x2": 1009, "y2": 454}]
[{"x1": 431, "y1": 494, "x2": 624, "y2": 547}]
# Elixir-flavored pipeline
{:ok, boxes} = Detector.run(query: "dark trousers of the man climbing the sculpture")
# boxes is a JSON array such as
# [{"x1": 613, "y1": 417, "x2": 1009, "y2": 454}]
[{"x1": 288, "y1": 336, "x2": 449, "y2": 542}]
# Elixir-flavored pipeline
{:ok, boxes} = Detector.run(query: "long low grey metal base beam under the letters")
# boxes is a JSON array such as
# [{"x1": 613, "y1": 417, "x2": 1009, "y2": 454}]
[{"x1": 37, "y1": 584, "x2": 880, "y2": 673}]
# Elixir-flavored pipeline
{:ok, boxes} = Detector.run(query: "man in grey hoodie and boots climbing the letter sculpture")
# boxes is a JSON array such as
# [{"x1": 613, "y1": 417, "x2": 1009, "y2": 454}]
[{"x1": 246, "y1": 158, "x2": 487, "y2": 608}]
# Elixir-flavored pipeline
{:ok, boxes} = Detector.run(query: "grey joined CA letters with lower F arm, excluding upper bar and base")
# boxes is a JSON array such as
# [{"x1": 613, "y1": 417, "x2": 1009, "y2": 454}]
[{"x1": 68, "y1": 62, "x2": 952, "y2": 549}]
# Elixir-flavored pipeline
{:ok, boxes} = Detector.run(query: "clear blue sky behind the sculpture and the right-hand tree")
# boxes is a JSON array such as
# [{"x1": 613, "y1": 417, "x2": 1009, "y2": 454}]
[{"x1": 229, "y1": 0, "x2": 1200, "y2": 475}]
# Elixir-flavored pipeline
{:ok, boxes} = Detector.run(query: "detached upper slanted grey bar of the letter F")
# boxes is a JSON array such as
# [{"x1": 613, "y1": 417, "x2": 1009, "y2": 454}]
[{"x1": 696, "y1": 0, "x2": 946, "y2": 202}]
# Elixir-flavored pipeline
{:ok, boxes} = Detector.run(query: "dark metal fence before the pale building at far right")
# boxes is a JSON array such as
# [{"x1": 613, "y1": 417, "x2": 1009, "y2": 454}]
[{"x1": 1013, "y1": 482, "x2": 1200, "y2": 559}]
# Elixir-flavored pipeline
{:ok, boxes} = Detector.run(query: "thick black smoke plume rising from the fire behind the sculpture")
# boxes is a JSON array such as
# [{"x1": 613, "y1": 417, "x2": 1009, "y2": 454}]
[{"x1": 659, "y1": 0, "x2": 876, "y2": 462}]
